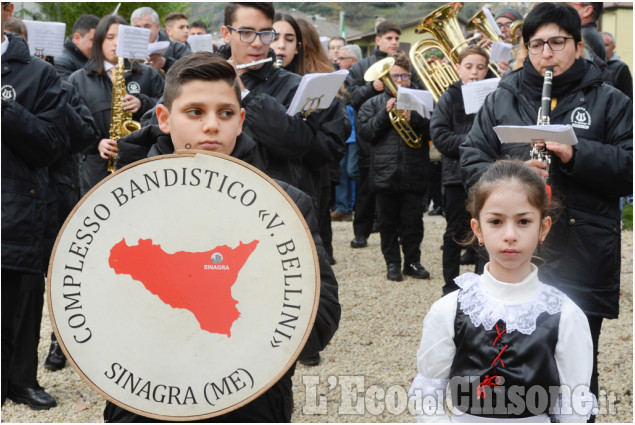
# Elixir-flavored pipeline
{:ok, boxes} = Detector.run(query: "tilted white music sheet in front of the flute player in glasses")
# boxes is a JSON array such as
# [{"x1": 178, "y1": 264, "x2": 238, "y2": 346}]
[{"x1": 287, "y1": 69, "x2": 348, "y2": 116}]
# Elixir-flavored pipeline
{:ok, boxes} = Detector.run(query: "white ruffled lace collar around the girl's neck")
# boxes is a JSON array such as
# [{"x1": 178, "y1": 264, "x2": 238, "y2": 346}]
[{"x1": 455, "y1": 266, "x2": 567, "y2": 335}]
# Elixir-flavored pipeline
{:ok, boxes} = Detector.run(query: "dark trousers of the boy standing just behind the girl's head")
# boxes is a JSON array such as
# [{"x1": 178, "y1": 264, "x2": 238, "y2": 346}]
[{"x1": 442, "y1": 184, "x2": 470, "y2": 295}]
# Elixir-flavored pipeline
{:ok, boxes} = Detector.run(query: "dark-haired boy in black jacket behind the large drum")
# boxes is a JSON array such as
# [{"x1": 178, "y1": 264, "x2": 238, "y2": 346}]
[{"x1": 104, "y1": 52, "x2": 341, "y2": 422}]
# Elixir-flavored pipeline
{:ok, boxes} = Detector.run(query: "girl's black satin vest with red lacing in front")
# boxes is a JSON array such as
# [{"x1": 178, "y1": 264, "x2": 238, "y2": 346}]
[{"x1": 450, "y1": 296, "x2": 560, "y2": 419}]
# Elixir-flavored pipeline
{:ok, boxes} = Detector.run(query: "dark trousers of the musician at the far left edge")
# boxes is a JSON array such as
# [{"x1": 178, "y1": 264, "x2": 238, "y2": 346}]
[{"x1": 2, "y1": 269, "x2": 44, "y2": 401}]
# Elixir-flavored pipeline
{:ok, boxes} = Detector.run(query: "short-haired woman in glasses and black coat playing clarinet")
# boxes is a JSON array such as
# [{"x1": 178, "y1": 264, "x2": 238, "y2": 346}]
[{"x1": 460, "y1": 3, "x2": 633, "y2": 416}]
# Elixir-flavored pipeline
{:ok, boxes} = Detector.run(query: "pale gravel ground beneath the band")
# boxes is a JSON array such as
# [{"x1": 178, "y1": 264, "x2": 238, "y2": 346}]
[{"x1": 1, "y1": 215, "x2": 633, "y2": 423}]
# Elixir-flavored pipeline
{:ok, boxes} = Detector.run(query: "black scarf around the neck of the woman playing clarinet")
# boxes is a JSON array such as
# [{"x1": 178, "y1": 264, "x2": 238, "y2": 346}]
[{"x1": 521, "y1": 56, "x2": 587, "y2": 102}]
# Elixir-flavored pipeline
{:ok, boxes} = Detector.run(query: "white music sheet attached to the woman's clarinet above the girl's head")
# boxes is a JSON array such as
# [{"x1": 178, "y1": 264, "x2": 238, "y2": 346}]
[{"x1": 494, "y1": 124, "x2": 578, "y2": 146}]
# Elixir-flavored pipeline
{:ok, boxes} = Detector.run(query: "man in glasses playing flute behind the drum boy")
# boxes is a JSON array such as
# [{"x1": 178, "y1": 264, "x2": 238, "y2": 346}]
[{"x1": 218, "y1": 2, "x2": 319, "y2": 187}]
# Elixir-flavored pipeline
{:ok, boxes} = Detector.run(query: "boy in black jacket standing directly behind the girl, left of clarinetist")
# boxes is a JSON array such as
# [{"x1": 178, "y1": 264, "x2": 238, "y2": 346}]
[{"x1": 430, "y1": 45, "x2": 489, "y2": 295}]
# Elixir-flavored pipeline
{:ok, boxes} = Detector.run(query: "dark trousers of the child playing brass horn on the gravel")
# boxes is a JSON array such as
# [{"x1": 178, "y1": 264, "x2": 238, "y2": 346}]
[{"x1": 375, "y1": 192, "x2": 423, "y2": 264}]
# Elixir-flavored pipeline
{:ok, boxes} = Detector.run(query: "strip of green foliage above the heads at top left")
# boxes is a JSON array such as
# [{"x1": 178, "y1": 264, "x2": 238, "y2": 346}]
[{"x1": 38, "y1": 2, "x2": 191, "y2": 35}]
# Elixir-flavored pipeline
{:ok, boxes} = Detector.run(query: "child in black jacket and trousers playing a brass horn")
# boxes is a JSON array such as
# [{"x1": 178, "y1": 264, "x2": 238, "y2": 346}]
[{"x1": 358, "y1": 53, "x2": 430, "y2": 281}]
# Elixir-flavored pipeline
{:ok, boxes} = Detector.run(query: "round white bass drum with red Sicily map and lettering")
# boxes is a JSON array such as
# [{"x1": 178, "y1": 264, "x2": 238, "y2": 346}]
[{"x1": 47, "y1": 151, "x2": 319, "y2": 421}]
